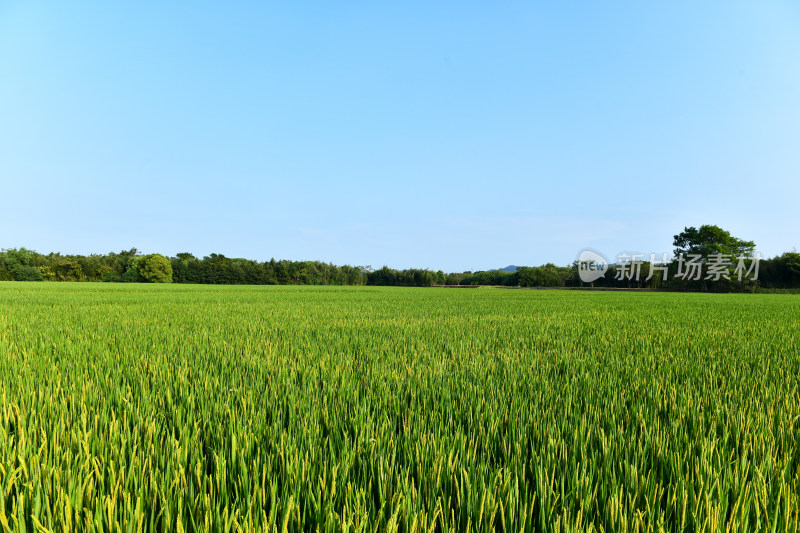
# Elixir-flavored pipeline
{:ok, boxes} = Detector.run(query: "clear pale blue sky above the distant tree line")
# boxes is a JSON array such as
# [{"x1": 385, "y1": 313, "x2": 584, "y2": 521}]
[{"x1": 0, "y1": 0, "x2": 800, "y2": 271}]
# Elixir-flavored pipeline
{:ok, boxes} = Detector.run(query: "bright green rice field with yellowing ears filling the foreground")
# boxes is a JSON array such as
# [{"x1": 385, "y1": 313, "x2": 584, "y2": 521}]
[{"x1": 0, "y1": 283, "x2": 800, "y2": 531}]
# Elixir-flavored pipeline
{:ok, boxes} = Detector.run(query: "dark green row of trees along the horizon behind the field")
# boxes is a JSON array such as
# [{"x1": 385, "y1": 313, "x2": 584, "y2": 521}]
[{"x1": 0, "y1": 225, "x2": 800, "y2": 291}]
